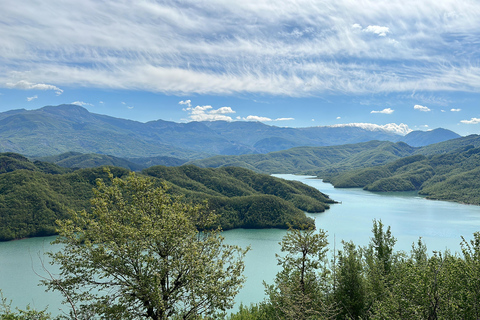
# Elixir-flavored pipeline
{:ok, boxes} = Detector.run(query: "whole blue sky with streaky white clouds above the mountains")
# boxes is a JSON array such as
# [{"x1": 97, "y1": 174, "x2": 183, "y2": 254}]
[{"x1": 0, "y1": 0, "x2": 480, "y2": 135}]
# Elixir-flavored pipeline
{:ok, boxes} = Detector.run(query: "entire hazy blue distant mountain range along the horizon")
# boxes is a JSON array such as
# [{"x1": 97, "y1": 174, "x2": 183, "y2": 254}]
[{"x1": 0, "y1": 105, "x2": 459, "y2": 160}]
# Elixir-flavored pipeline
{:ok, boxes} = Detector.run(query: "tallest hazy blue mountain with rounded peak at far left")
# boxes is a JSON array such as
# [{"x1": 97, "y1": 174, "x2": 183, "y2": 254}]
[{"x1": 0, "y1": 105, "x2": 208, "y2": 159}]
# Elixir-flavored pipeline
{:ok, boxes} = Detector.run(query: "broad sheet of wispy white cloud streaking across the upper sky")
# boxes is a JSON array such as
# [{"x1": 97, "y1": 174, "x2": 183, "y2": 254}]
[{"x1": 0, "y1": 0, "x2": 480, "y2": 96}]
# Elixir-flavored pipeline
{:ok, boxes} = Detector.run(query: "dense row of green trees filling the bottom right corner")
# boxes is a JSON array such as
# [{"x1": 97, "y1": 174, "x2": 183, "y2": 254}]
[{"x1": 228, "y1": 221, "x2": 480, "y2": 320}]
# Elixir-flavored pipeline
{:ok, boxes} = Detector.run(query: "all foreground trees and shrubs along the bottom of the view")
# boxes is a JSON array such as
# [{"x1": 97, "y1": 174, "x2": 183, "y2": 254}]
[{"x1": 0, "y1": 175, "x2": 480, "y2": 320}]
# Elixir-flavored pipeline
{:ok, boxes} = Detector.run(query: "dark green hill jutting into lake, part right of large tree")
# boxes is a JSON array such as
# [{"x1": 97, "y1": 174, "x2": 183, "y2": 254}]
[{"x1": 142, "y1": 165, "x2": 334, "y2": 229}]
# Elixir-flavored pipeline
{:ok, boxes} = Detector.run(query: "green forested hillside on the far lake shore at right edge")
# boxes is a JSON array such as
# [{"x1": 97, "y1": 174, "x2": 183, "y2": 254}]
[{"x1": 328, "y1": 145, "x2": 480, "y2": 205}]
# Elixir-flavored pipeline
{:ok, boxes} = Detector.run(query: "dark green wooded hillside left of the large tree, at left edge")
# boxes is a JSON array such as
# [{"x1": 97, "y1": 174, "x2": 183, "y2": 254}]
[{"x1": 0, "y1": 161, "x2": 126, "y2": 241}]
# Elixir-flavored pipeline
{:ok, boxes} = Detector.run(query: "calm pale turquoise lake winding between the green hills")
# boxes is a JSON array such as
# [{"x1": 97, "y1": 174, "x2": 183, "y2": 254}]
[{"x1": 0, "y1": 175, "x2": 480, "y2": 314}]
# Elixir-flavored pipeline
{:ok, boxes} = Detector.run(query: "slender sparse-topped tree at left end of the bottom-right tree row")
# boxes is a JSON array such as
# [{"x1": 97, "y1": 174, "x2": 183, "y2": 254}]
[{"x1": 266, "y1": 228, "x2": 332, "y2": 320}]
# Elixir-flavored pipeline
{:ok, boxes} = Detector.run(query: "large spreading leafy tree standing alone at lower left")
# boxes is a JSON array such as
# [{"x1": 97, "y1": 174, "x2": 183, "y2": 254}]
[{"x1": 44, "y1": 173, "x2": 248, "y2": 320}]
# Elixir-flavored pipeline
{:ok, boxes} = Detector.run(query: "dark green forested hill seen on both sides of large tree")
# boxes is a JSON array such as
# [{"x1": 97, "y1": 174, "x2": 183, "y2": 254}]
[{"x1": 0, "y1": 153, "x2": 333, "y2": 240}]
